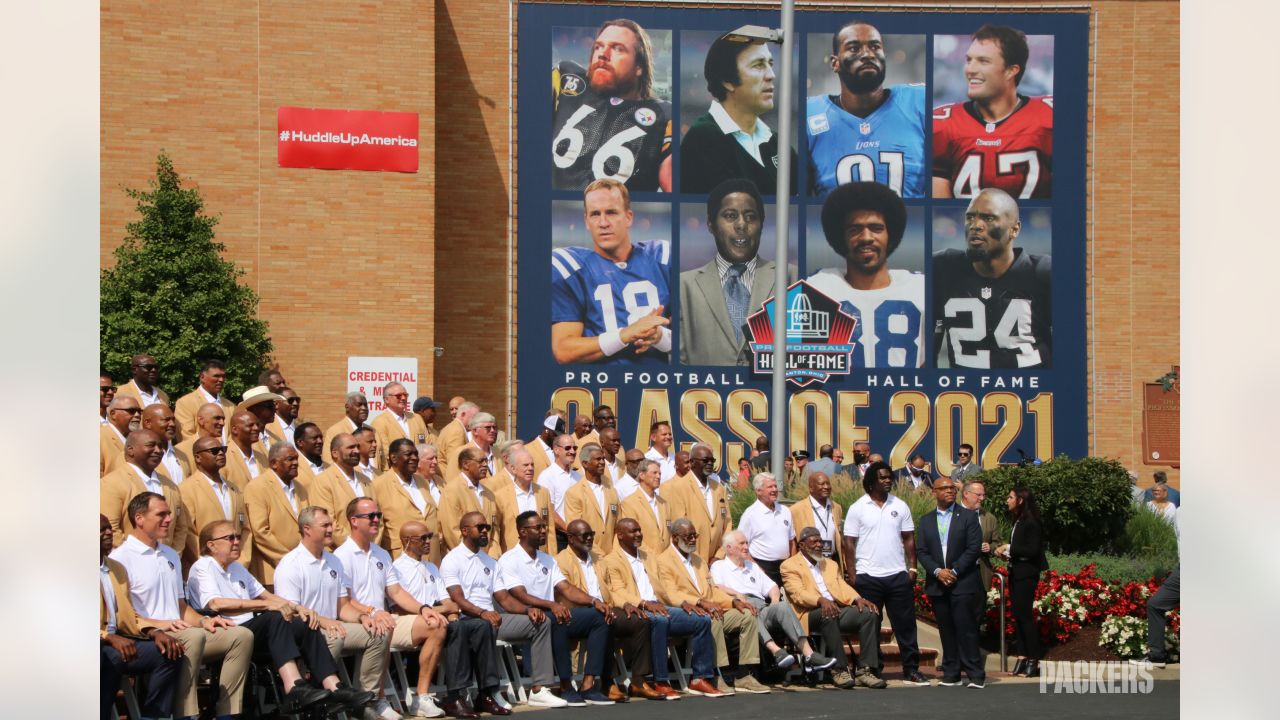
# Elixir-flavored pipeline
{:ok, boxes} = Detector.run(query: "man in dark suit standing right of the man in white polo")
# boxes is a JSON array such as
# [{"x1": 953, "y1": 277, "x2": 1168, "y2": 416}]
[{"x1": 915, "y1": 478, "x2": 987, "y2": 689}]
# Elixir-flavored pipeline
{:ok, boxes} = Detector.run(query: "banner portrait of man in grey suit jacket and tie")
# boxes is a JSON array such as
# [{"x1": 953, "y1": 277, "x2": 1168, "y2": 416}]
[{"x1": 677, "y1": 178, "x2": 800, "y2": 365}]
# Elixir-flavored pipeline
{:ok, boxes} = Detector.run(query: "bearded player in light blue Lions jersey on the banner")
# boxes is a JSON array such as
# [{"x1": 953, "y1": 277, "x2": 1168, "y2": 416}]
[{"x1": 805, "y1": 20, "x2": 927, "y2": 197}]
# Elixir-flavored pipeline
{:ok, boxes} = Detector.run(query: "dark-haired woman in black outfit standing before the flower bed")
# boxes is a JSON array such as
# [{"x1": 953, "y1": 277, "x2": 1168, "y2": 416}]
[{"x1": 997, "y1": 487, "x2": 1048, "y2": 678}]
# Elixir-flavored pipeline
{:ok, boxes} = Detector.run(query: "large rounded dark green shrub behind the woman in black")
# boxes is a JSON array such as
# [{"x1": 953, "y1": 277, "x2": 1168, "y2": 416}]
[{"x1": 967, "y1": 455, "x2": 1134, "y2": 552}]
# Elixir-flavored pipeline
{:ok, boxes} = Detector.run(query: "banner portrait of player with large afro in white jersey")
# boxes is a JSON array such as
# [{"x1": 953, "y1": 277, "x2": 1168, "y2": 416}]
[{"x1": 805, "y1": 182, "x2": 928, "y2": 368}]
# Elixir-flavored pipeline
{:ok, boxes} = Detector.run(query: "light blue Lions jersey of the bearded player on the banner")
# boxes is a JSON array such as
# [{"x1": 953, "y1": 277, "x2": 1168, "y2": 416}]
[{"x1": 805, "y1": 85, "x2": 925, "y2": 197}]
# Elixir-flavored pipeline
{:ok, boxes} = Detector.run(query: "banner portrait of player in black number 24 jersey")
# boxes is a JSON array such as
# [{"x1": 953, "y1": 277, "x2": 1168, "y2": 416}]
[{"x1": 932, "y1": 188, "x2": 1053, "y2": 370}]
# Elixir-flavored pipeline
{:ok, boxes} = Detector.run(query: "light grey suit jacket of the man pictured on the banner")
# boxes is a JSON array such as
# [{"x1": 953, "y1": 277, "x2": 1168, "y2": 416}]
[{"x1": 680, "y1": 258, "x2": 796, "y2": 365}]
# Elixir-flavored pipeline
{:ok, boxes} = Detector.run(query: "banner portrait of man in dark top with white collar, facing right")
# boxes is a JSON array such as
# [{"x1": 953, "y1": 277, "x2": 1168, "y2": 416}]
[{"x1": 680, "y1": 31, "x2": 797, "y2": 195}]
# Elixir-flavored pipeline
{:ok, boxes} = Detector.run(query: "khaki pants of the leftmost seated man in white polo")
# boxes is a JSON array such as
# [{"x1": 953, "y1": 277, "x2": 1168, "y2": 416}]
[{"x1": 169, "y1": 620, "x2": 253, "y2": 717}]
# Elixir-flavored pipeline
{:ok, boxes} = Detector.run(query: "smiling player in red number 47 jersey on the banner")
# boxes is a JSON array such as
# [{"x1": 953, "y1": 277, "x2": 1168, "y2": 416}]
[{"x1": 933, "y1": 24, "x2": 1053, "y2": 199}]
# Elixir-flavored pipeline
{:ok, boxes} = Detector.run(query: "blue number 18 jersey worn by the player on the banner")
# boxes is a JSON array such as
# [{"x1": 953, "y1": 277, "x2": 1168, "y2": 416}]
[{"x1": 552, "y1": 240, "x2": 671, "y2": 364}]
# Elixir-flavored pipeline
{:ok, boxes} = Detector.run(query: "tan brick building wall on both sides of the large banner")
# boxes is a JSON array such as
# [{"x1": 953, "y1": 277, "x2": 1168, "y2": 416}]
[{"x1": 101, "y1": 0, "x2": 1179, "y2": 484}]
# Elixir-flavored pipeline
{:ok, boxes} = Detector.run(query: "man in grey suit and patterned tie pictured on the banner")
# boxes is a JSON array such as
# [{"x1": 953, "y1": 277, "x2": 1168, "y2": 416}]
[{"x1": 680, "y1": 178, "x2": 796, "y2": 365}]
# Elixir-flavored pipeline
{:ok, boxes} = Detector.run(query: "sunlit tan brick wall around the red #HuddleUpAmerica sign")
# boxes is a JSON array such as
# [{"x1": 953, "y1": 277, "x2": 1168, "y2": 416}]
[{"x1": 101, "y1": 0, "x2": 436, "y2": 427}]
